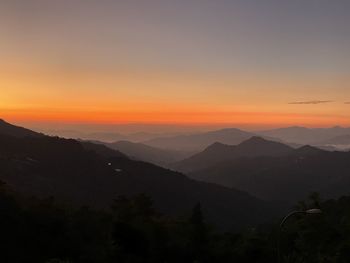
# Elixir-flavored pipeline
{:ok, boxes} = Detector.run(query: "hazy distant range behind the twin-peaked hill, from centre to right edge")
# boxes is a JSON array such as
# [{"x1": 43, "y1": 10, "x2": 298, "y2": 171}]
[{"x1": 143, "y1": 127, "x2": 350, "y2": 152}]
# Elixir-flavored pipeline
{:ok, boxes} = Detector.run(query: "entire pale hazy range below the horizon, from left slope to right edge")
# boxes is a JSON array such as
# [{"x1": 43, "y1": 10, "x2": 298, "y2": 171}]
[{"x1": 42, "y1": 126, "x2": 350, "y2": 153}]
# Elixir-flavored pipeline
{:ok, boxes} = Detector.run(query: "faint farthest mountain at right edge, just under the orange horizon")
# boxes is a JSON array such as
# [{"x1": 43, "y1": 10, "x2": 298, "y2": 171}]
[{"x1": 256, "y1": 126, "x2": 350, "y2": 145}]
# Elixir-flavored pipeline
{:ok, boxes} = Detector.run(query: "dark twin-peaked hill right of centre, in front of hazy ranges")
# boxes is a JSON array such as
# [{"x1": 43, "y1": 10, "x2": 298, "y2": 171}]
[{"x1": 171, "y1": 136, "x2": 293, "y2": 173}]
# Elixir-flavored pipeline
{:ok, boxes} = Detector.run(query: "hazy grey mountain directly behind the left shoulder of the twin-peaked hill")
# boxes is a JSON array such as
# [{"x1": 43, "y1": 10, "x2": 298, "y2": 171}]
[{"x1": 144, "y1": 128, "x2": 254, "y2": 152}]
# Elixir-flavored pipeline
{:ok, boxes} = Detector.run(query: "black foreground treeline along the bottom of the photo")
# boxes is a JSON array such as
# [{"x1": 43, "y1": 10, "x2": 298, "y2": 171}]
[{"x1": 0, "y1": 185, "x2": 350, "y2": 263}]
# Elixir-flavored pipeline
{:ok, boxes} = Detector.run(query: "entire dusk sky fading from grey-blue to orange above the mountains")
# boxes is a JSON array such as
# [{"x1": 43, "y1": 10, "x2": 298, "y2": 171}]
[{"x1": 0, "y1": 0, "x2": 350, "y2": 132}]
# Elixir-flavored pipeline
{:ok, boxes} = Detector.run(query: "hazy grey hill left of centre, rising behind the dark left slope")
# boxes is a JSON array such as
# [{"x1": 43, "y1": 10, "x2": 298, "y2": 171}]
[{"x1": 104, "y1": 141, "x2": 191, "y2": 165}]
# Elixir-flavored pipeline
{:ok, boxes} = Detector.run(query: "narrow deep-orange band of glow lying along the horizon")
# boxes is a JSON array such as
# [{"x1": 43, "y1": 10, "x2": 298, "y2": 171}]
[{"x1": 0, "y1": 106, "x2": 350, "y2": 127}]
